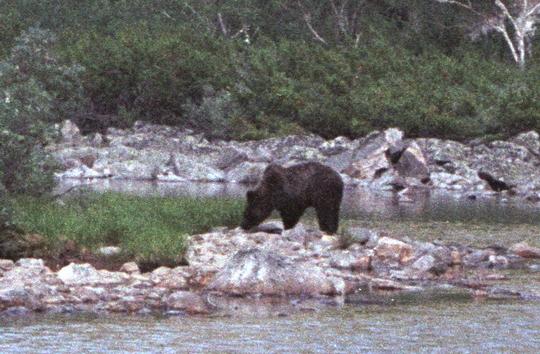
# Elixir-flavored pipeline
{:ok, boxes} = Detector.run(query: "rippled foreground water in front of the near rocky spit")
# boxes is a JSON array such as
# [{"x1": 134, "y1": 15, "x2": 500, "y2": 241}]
[{"x1": 0, "y1": 296, "x2": 540, "y2": 353}]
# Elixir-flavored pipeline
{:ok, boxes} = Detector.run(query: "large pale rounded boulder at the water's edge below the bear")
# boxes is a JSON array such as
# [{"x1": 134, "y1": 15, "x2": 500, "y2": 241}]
[{"x1": 208, "y1": 248, "x2": 337, "y2": 296}]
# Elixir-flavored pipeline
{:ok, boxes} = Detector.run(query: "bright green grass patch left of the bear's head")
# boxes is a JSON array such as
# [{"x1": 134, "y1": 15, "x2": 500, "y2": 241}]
[{"x1": 14, "y1": 193, "x2": 243, "y2": 264}]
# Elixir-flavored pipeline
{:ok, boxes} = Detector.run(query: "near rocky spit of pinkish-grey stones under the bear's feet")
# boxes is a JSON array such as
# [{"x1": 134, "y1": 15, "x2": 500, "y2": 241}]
[{"x1": 0, "y1": 222, "x2": 540, "y2": 315}]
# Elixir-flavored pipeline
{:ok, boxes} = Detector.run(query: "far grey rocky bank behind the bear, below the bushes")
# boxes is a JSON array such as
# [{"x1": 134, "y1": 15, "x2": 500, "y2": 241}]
[{"x1": 48, "y1": 121, "x2": 540, "y2": 203}]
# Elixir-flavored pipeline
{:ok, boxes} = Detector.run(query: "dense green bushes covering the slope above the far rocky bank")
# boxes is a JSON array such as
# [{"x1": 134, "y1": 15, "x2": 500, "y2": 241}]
[{"x1": 0, "y1": 0, "x2": 540, "y2": 140}]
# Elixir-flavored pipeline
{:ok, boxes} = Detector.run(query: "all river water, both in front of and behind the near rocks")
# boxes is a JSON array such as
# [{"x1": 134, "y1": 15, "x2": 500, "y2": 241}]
[{"x1": 0, "y1": 181, "x2": 540, "y2": 353}]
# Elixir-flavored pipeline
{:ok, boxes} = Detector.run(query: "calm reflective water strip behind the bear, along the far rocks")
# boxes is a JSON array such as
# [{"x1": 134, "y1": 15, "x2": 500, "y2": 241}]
[{"x1": 58, "y1": 180, "x2": 540, "y2": 224}]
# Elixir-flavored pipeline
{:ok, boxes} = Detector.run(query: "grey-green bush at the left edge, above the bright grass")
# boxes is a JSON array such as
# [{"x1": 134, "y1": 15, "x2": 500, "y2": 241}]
[{"x1": 0, "y1": 28, "x2": 83, "y2": 195}]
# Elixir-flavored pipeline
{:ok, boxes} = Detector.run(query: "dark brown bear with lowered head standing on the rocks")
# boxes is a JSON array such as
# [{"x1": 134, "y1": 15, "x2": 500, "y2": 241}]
[{"x1": 240, "y1": 162, "x2": 343, "y2": 233}]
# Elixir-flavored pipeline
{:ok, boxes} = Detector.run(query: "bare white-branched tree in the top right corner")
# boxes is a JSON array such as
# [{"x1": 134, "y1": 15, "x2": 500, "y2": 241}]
[{"x1": 435, "y1": 0, "x2": 540, "y2": 68}]
